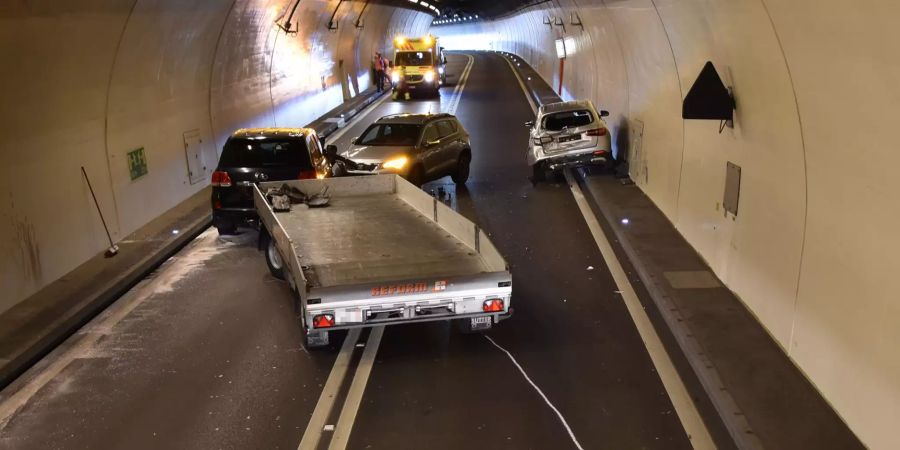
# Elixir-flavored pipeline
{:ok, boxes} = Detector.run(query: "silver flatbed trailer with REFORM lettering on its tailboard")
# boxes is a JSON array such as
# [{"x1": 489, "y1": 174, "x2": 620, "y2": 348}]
[{"x1": 254, "y1": 175, "x2": 512, "y2": 347}]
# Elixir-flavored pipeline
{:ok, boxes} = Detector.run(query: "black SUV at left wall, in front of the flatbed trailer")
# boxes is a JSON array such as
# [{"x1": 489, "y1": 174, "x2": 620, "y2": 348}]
[{"x1": 212, "y1": 128, "x2": 336, "y2": 234}]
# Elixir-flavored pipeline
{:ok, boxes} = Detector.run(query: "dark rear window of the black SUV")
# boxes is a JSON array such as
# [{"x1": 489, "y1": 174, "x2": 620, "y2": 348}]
[{"x1": 219, "y1": 138, "x2": 312, "y2": 168}]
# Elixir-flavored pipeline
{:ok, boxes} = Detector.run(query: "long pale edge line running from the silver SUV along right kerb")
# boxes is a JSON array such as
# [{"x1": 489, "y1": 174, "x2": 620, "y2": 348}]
[{"x1": 566, "y1": 171, "x2": 716, "y2": 450}]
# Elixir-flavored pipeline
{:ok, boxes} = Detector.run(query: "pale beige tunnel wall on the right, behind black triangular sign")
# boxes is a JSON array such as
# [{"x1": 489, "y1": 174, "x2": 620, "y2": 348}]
[{"x1": 432, "y1": 0, "x2": 900, "y2": 448}]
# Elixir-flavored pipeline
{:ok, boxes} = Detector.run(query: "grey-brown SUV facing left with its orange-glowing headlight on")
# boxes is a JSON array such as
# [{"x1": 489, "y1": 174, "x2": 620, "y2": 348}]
[{"x1": 341, "y1": 114, "x2": 472, "y2": 186}]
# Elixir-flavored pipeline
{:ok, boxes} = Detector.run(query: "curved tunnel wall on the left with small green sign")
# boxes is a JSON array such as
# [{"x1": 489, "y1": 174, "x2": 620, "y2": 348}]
[{"x1": 0, "y1": 0, "x2": 432, "y2": 312}]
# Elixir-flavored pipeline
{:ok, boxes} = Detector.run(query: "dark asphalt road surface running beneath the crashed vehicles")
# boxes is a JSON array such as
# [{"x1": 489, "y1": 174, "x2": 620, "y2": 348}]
[{"x1": 0, "y1": 53, "x2": 691, "y2": 449}]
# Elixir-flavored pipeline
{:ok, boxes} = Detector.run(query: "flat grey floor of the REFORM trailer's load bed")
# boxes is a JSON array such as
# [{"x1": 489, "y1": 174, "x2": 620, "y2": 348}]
[{"x1": 279, "y1": 194, "x2": 490, "y2": 288}]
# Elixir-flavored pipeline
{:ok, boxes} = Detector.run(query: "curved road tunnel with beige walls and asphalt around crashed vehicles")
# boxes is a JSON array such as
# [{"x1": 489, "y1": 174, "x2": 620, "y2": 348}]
[{"x1": 0, "y1": 0, "x2": 900, "y2": 449}]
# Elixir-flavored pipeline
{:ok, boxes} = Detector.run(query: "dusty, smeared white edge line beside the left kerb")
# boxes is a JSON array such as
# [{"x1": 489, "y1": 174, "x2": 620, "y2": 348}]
[{"x1": 0, "y1": 228, "x2": 223, "y2": 430}]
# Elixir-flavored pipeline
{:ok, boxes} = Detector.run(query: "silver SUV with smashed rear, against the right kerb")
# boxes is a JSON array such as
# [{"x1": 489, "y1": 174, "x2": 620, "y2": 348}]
[{"x1": 525, "y1": 100, "x2": 612, "y2": 182}]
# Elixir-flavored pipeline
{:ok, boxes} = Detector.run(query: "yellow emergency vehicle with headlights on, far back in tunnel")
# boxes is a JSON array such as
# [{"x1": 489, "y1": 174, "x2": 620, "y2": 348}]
[{"x1": 391, "y1": 34, "x2": 447, "y2": 99}]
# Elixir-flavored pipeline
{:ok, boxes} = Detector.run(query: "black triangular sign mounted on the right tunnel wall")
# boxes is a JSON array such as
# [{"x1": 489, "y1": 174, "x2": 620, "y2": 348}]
[{"x1": 681, "y1": 61, "x2": 734, "y2": 120}]
